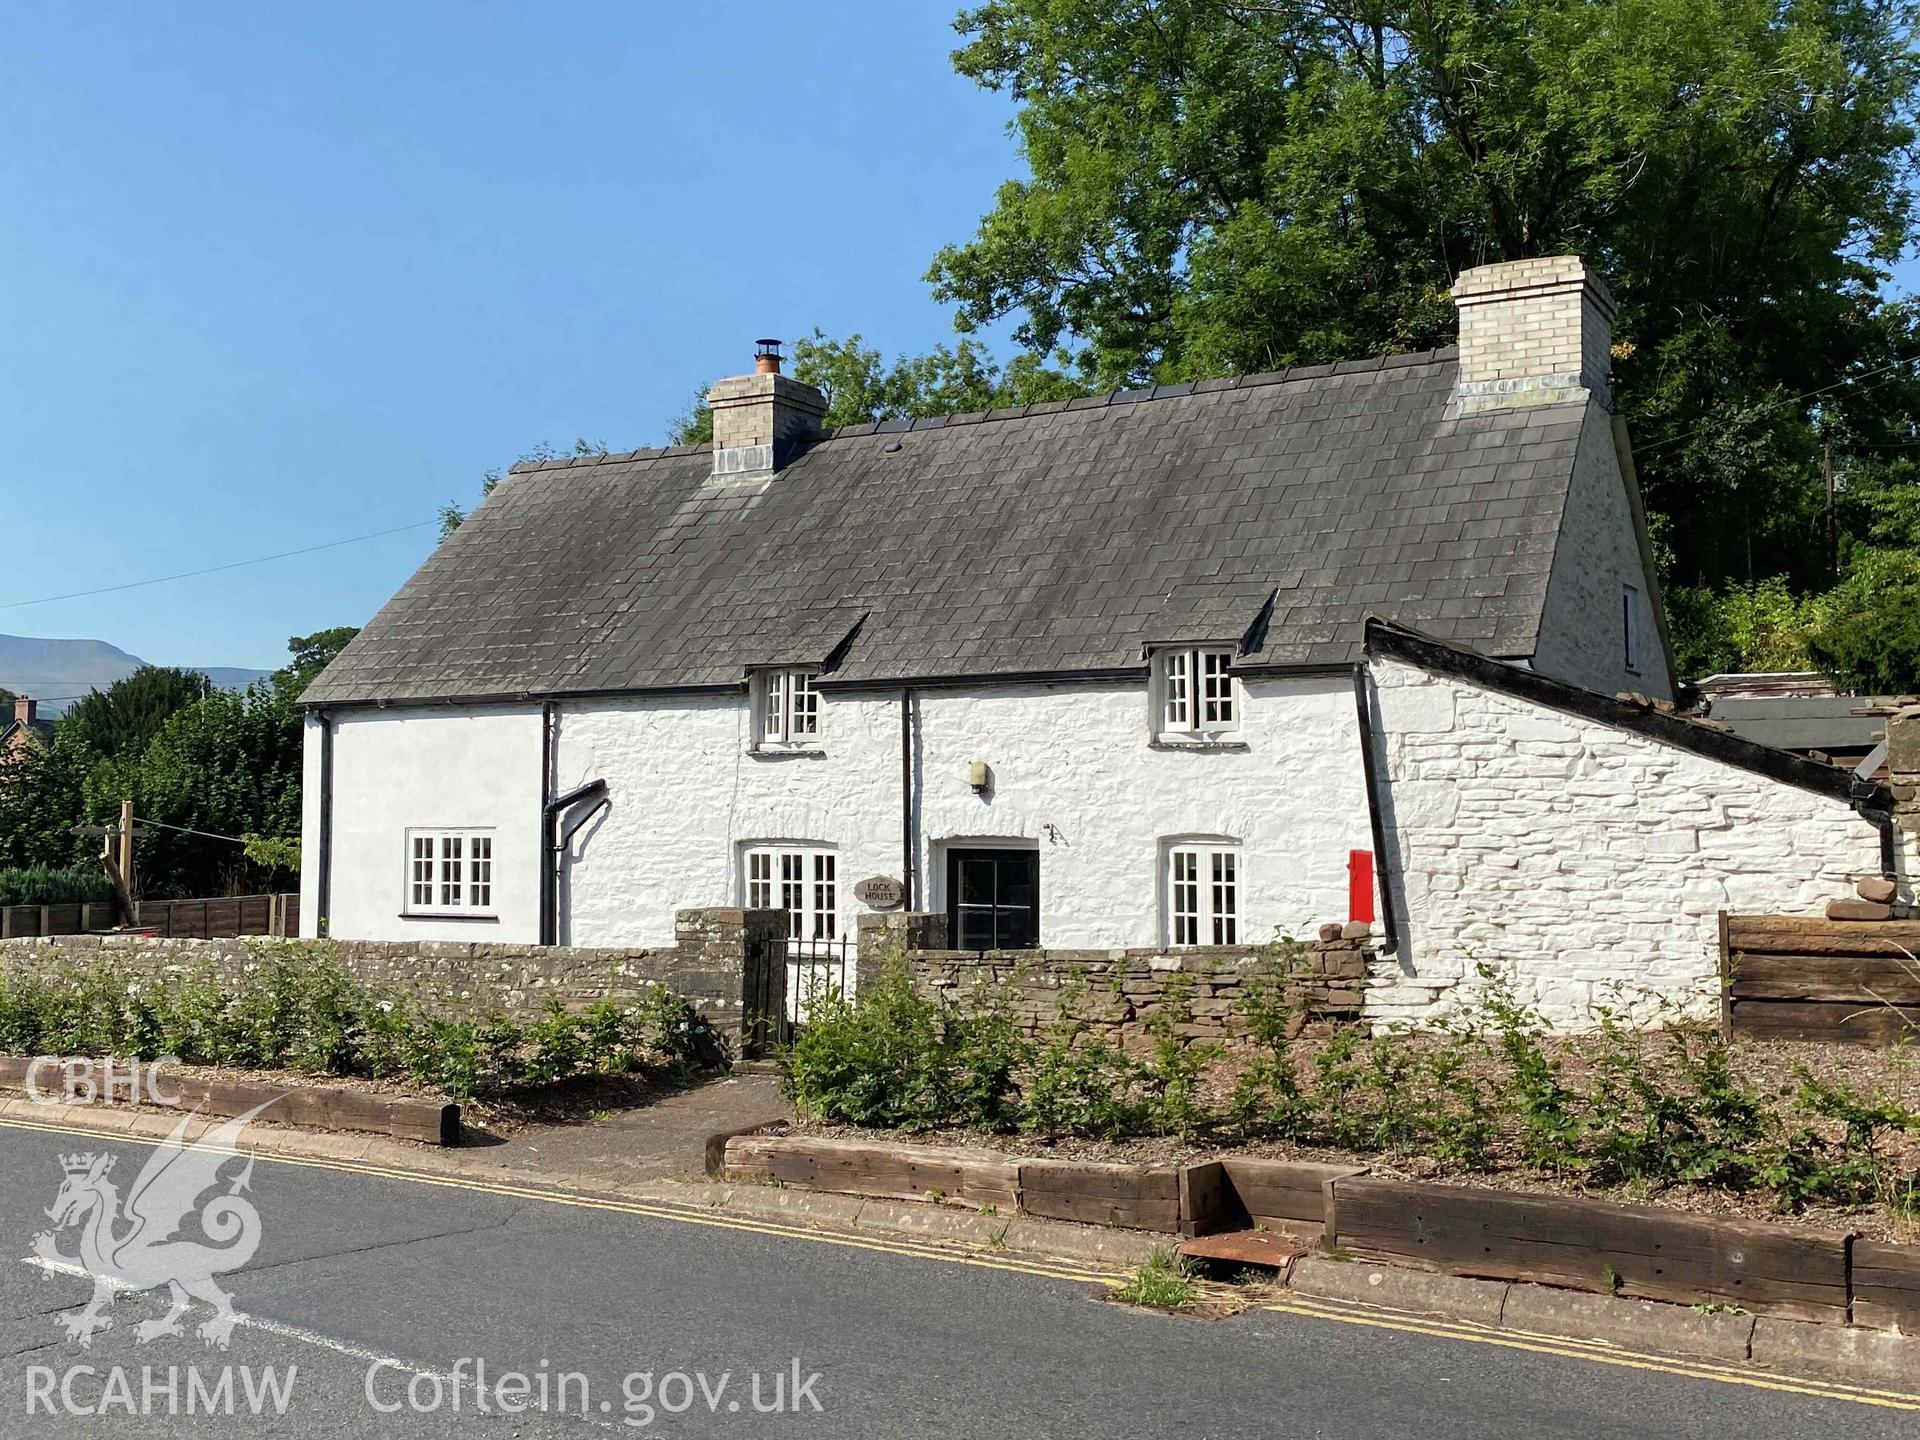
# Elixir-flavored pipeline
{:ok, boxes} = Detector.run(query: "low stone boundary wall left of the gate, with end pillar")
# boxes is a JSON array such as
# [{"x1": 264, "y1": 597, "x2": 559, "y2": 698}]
[{"x1": 0, "y1": 908, "x2": 785, "y2": 1035}]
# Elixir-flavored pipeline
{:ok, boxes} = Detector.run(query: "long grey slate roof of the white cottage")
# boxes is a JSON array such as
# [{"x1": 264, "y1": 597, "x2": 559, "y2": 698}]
[{"x1": 305, "y1": 351, "x2": 1582, "y2": 705}]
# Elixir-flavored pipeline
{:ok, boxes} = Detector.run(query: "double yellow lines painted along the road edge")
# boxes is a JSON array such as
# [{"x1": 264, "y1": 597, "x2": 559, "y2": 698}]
[{"x1": 0, "y1": 1117, "x2": 1920, "y2": 1411}]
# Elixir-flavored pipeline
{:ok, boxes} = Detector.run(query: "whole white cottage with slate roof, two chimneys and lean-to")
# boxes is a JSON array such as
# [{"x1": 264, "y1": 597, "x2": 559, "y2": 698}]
[{"x1": 301, "y1": 259, "x2": 1897, "y2": 1023}]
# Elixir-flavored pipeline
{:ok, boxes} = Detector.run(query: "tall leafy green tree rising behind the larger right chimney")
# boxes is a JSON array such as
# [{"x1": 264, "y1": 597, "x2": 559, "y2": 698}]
[{"x1": 929, "y1": 0, "x2": 1920, "y2": 588}]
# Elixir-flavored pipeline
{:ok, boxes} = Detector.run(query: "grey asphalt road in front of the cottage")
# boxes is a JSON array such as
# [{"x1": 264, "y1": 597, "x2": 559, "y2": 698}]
[{"x1": 0, "y1": 1125, "x2": 1920, "y2": 1440}]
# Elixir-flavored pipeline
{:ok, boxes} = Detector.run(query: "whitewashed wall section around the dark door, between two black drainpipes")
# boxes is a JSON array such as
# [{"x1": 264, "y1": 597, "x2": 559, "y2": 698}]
[{"x1": 910, "y1": 676, "x2": 1373, "y2": 947}]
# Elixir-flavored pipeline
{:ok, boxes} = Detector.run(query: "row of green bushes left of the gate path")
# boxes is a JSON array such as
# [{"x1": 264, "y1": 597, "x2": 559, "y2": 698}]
[{"x1": 0, "y1": 941, "x2": 726, "y2": 1098}]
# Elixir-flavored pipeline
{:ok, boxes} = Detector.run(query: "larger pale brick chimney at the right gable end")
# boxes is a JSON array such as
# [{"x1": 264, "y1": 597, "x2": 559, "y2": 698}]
[{"x1": 1453, "y1": 255, "x2": 1613, "y2": 413}]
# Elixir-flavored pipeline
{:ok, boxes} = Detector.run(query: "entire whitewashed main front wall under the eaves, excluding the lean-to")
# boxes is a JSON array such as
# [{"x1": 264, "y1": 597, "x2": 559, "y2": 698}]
[{"x1": 303, "y1": 678, "x2": 1371, "y2": 947}]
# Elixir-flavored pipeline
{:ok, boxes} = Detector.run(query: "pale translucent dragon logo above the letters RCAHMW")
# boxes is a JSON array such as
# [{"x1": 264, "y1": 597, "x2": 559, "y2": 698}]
[{"x1": 29, "y1": 1100, "x2": 273, "y2": 1350}]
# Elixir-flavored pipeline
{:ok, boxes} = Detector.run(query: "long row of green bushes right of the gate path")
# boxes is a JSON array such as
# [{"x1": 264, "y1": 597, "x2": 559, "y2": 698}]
[{"x1": 779, "y1": 941, "x2": 1920, "y2": 1212}]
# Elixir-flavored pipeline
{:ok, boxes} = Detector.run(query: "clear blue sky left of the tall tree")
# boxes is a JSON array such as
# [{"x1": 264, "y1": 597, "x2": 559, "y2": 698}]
[{"x1": 0, "y1": 0, "x2": 1018, "y2": 666}]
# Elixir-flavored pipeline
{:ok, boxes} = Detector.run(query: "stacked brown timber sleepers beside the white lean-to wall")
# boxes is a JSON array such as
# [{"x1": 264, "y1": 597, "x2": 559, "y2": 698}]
[{"x1": 1720, "y1": 916, "x2": 1920, "y2": 1044}]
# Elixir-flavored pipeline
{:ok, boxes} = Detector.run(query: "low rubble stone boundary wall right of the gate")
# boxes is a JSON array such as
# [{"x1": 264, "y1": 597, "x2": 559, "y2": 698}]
[{"x1": 860, "y1": 914, "x2": 1377, "y2": 1044}]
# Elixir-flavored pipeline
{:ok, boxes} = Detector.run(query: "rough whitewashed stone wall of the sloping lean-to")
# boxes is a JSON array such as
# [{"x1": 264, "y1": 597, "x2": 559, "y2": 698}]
[{"x1": 1367, "y1": 660, "x2": 1880, "y2": 1029}]
